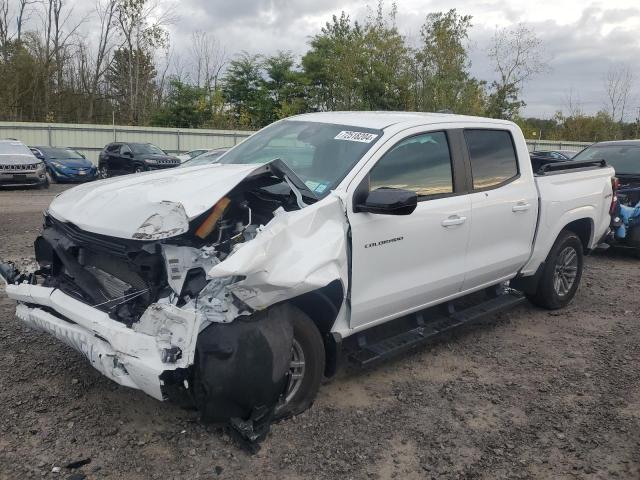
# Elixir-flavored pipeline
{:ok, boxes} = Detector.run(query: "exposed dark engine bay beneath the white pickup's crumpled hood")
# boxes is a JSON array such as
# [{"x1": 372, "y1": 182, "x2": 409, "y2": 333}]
[{"x1": 36, "y1": 171, "x2": 299, "y2": 327}]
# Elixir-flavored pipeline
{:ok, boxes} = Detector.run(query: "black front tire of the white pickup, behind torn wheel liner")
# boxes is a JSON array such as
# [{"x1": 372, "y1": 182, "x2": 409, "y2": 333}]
[{"x1": 275, "y1": 307, "x2": 325, "y2": 420}]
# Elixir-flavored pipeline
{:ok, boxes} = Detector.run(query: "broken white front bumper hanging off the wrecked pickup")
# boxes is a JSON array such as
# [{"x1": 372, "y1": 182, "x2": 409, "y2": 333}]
[{"x1": 6, "y1": 283, "x2": 199, "y2": 400}]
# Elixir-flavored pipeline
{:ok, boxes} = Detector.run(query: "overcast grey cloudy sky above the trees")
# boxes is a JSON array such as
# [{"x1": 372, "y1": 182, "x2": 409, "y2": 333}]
[{"x1": 33, "y1": 0, "x2": 640, "y2": 119}]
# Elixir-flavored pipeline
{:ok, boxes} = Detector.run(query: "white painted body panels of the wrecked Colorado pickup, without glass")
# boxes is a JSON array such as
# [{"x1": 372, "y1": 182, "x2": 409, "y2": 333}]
[{"x1": 1, "y1": 112, "x2": 613, "y2": 398}]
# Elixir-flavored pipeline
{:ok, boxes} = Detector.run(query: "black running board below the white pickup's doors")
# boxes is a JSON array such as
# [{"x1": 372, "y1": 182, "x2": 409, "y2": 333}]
[{"x1": 349, "y1": 293, "x2": 525, "y2": 367}]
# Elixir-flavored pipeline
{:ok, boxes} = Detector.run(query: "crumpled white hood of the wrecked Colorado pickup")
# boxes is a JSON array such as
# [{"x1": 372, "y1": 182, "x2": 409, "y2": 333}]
[{"x1": 49, "y1": 164, "x2": 267, "y2": 240}]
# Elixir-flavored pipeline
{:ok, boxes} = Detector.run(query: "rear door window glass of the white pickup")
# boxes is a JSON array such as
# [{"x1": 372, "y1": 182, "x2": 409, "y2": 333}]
[{"x1": 464, "y1": 130, "x2": 518, "y2": 190}]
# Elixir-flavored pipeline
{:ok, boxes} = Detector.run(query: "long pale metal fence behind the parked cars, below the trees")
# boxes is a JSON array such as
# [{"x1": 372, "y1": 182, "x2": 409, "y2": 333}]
[{"x1": 0, "y1": 122, "x2": 590, "y2": 163}]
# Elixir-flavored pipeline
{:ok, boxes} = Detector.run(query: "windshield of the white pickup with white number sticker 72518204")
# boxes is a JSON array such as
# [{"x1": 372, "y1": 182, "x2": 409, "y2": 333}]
[{"x1": 220, "y1": 120, "x2": 382, "y2": 197}]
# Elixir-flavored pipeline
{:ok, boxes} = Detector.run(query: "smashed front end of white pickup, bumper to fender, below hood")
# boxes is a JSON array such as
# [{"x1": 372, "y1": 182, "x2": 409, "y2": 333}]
[{"x1": 0, "y1": 165, "x2": 348, "y2": 441}]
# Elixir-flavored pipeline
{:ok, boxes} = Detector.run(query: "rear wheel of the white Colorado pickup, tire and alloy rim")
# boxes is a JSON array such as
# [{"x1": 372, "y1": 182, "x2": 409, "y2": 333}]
[{"x1": 527, "y1": 230, "x2": 584, "y2": 310}]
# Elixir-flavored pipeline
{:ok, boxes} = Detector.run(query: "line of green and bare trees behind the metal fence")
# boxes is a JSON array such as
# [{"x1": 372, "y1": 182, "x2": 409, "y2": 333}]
[{"x1": 0, "y1": 0, "x2": 640, "y2": 146}]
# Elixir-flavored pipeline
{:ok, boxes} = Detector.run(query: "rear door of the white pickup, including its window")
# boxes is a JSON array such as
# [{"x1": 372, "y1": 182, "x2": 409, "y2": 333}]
[{"x1": 463, "y1": 129, "x2": 538, "y2": 291}]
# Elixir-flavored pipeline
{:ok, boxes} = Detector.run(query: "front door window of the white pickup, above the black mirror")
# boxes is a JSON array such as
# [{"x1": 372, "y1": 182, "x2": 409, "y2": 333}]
[{"x1": 369, "y1": 132, "x2": 453, "y2": 197}]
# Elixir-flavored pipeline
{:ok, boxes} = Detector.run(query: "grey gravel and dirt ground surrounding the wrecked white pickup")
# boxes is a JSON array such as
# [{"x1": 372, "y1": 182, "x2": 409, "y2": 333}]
[{"x1": 0, "y1": 186, "x2": 640, "y2": 480}]
